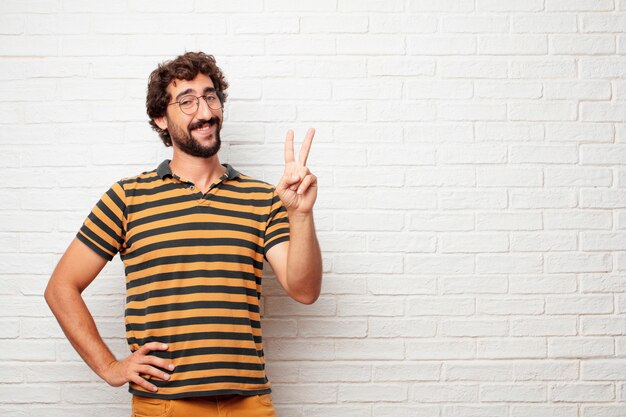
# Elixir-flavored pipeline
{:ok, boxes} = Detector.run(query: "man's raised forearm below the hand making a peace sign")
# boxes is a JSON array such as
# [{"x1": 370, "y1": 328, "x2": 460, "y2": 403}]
[{"x1": 287, "y1": 213, "x2": 322, "y2": 304}]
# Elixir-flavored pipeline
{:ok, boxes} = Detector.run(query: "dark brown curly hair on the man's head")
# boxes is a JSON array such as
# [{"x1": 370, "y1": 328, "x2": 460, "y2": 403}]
[{"x1": 146, "y1": 52, "x2": 228, "y2": 146}]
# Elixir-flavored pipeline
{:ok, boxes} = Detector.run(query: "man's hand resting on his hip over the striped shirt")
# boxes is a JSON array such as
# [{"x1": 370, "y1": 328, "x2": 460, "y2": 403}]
[{"x1": 102, "y1": 342, "x2": 174, "y2": 392}]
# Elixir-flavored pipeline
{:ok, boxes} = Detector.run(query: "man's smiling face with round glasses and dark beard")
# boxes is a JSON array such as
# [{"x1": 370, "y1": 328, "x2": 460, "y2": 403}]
[{"x1": 155, "y1": 73, "x2": 223, "y2": 158}]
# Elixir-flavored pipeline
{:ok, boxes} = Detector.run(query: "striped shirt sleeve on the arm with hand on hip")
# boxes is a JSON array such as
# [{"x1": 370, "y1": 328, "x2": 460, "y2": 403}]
[{"x1": 76, "y1": 182, "x2": 126, "y2": 261}]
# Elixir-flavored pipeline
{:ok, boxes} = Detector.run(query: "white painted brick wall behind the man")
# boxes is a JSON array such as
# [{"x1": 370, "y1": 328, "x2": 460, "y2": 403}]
[{"x1": 0, "y1": 0, "x2": 626, "y2": 417}]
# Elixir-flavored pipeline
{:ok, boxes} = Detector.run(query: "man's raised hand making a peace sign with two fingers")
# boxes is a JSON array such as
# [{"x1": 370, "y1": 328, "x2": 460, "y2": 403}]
[{"x1": 276, "y1": 128, "x2": 317, "y2": 214}]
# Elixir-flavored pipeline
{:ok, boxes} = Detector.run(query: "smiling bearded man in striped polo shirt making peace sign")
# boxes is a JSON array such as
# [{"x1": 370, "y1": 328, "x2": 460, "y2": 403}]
[{"x1": 45, "y1": 52, "x2": 322, "y2": 417}]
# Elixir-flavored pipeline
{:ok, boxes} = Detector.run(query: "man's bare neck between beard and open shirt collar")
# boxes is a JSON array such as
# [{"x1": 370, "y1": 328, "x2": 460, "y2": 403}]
[{"x1": 170, "y1": 146, "x2": 226, "y2": 189}]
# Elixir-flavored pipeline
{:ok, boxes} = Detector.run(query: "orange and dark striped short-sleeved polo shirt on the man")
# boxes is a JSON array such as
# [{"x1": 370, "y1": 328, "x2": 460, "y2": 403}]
[{"x1": 77, "y1": 160, "x2": 289, "y2": 399}]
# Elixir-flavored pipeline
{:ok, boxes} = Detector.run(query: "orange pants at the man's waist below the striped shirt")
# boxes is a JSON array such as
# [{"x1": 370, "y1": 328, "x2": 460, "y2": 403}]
[{"x1": 132, "y1": 394, "x2": 276, "y2": 417}]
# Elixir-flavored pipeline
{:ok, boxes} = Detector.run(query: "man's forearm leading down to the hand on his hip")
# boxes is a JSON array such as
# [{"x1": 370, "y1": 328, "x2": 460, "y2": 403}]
[{"x1": 45, "y1": 283, "x2": 116, "y2": 380}]
